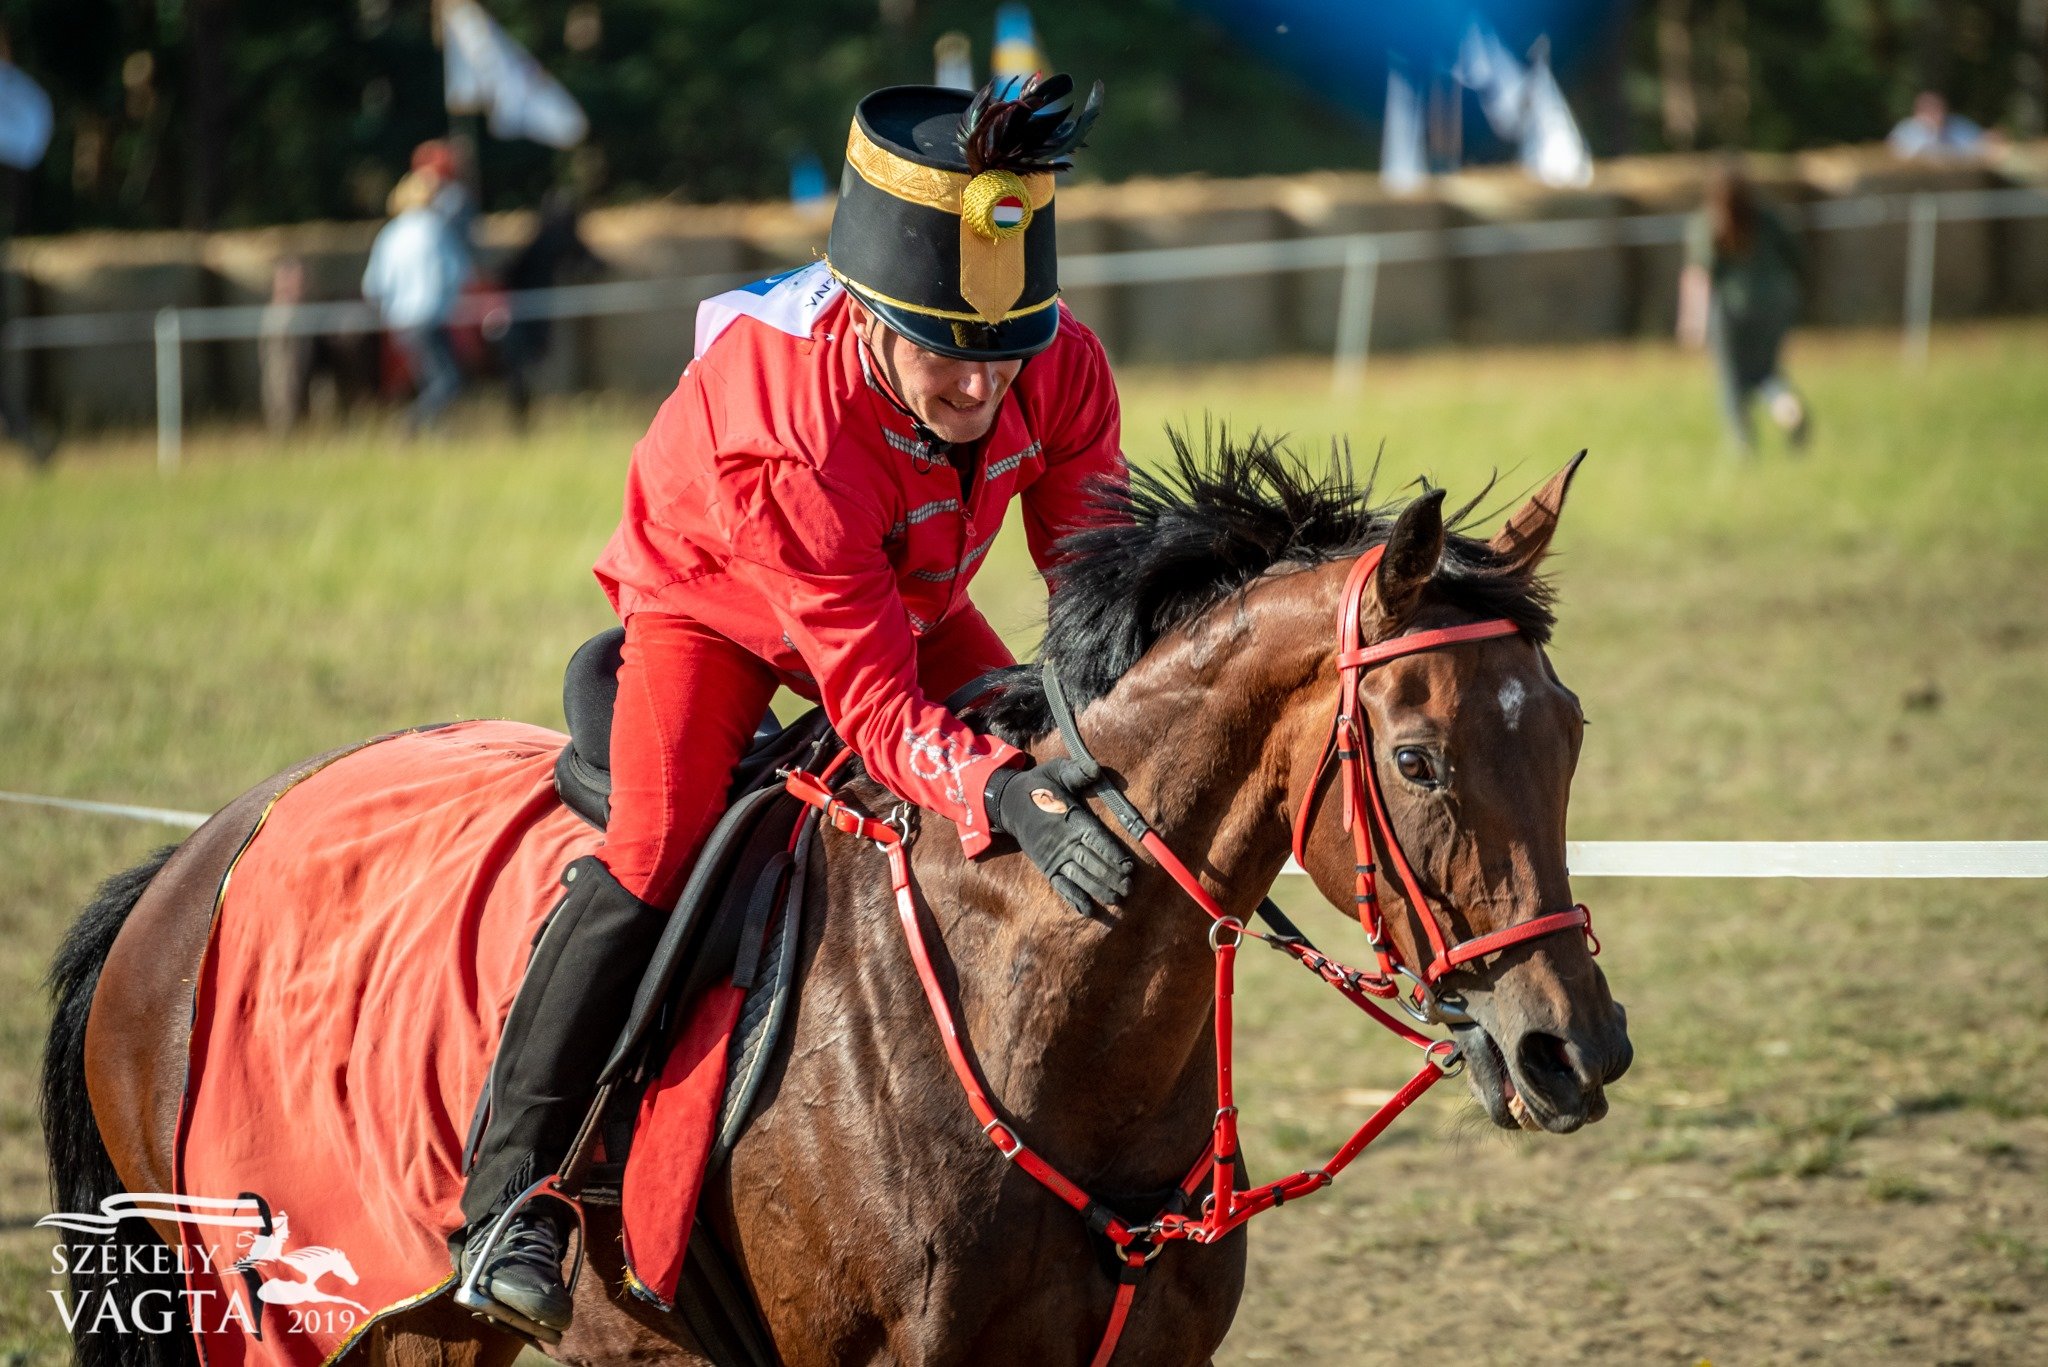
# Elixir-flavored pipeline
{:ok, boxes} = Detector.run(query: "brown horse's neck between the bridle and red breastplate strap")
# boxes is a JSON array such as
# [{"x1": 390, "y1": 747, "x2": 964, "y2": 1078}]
[{"x1": 948, "y1": 582, "x2": 1323, "y2": 1191}]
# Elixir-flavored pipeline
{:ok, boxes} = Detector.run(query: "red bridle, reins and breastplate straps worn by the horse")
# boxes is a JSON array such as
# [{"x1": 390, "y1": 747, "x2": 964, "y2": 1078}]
[{"x1": 784, "y1": 547, "x2": 1599, "y2": 1367}]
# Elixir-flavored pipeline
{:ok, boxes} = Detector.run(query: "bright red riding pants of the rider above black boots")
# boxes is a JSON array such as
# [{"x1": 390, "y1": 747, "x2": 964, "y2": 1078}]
[{"x1": 598, "y1": 607, "x2": 1016, "y2": 906}]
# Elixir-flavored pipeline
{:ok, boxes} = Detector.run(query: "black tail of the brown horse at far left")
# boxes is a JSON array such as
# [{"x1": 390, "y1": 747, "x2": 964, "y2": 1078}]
[{"x1": 43, "y1": 844, "x2": 197, "y2": 1367}]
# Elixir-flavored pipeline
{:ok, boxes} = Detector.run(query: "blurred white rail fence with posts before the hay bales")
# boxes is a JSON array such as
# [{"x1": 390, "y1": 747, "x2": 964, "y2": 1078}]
[{"x1": 0, "y1": 187, "x2": 2048, "y2": 471}]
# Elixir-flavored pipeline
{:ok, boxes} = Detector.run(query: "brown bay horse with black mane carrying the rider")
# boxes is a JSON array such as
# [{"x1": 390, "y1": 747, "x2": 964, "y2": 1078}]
[{"x1": 45, "y1": 441, "x2": 1630, "y2": 1367}]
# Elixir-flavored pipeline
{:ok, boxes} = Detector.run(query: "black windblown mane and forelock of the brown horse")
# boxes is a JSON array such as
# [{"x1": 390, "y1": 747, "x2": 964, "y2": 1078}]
[{"x1": 971, "y1": 428, "x2": 1554, "y2": 744}]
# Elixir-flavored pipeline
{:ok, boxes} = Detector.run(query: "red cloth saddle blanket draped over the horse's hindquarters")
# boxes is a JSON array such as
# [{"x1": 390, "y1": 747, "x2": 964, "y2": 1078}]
[{"x1": 176, "y1": 721, "x2": 737, "y2": 1367}]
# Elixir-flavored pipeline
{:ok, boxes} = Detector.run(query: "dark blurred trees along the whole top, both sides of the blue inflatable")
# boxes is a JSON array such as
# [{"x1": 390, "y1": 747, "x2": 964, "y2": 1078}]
[{"x1": 0, "y1": 0, "x2": 2048, "y2": 234}]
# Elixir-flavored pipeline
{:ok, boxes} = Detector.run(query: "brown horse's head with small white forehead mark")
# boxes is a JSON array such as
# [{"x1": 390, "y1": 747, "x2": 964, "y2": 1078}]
[{"x1": 1292, "y1": 459, "x2": 1632, "y2": 1133}]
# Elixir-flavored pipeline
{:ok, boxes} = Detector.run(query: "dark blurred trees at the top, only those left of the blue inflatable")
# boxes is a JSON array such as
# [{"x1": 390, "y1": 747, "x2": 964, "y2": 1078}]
[{"x1": 0, "y1": 0, "x2": 1374, "y2": 232}]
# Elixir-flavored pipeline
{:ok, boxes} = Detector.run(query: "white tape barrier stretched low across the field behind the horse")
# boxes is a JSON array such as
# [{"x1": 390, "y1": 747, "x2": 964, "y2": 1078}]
[{"x1": 0, "y1": 791, "x2": 2048, "y2": 879}]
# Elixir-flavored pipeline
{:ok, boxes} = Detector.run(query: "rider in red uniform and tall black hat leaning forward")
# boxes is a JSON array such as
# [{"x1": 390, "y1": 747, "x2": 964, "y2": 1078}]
[{"x1": 457, "y1": 78, "x2": 1130, "y2": 1338}]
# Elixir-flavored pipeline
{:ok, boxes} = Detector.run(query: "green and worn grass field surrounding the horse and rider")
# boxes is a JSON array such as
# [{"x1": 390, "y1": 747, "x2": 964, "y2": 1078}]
[{"x1": 0, "y1": 324, "x2": 2048, "y2": 1367}]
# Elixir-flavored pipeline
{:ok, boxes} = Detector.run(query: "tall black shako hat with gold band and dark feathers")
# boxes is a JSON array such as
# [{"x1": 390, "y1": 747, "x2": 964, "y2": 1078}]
[{"x1": 825, "y1": 76, "x2": 1102, "y2": 361}]
